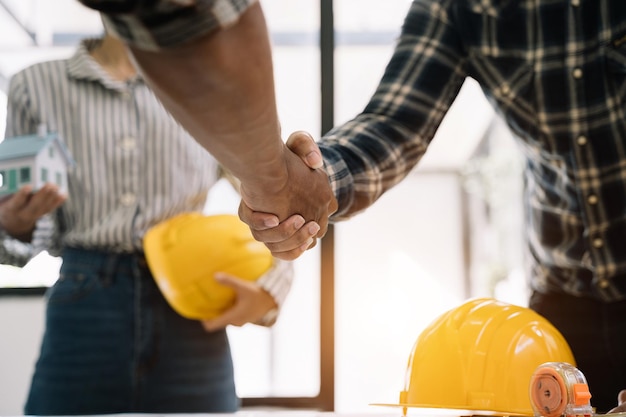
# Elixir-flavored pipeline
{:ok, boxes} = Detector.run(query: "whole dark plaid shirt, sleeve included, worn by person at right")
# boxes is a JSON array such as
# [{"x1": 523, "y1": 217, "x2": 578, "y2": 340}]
[{"x1": 320, "y1": 0, "x2": 626, "y2": 301}]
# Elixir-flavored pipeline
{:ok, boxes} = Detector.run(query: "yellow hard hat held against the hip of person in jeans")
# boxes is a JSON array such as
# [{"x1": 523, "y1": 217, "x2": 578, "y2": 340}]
[{"x1": 143, "y1": 213, "x2": 273, "y2": 319}]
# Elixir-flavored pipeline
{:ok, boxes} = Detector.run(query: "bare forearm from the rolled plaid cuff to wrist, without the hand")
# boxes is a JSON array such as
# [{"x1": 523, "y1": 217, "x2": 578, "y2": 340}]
[{"x1": 132, "y1": 4, "x2": 286, "y2": 203}]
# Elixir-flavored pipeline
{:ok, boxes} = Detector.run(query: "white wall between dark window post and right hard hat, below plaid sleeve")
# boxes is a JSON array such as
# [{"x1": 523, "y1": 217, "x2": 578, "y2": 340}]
[{"x1": 336, "y1": 174, "x2": 466, "y2": 413}]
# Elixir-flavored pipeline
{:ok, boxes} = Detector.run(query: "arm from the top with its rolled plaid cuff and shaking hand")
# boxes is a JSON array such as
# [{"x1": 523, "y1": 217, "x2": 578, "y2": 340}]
[{"x1": 81, "y1": 0, "x2": 335, "y2": 240}]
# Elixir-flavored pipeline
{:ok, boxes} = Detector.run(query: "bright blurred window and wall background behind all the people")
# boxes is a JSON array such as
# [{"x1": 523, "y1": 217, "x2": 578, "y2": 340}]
[{"x1": 0, "y1": 0, "x2": 527, "y2": 415}]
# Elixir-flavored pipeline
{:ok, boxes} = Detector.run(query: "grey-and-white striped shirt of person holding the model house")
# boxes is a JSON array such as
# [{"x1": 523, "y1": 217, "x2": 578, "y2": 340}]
[{"x1": 0, "y1": 40, "x2": 293, "y2": 312}]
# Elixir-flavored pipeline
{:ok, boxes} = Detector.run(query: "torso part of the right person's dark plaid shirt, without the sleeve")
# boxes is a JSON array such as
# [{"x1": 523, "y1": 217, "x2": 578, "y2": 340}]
[{"x1": 453, "y1": 0, "x2": 626, "y2": 298}]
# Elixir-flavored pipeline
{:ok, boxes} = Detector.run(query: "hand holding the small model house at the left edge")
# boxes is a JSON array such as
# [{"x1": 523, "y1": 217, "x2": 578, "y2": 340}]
[{"x1": 0, "y1": 183, "x2": 67, "y2": 242}]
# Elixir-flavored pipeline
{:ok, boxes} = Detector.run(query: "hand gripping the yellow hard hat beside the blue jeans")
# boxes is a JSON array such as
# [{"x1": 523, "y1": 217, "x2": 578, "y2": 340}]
[{"x1": 202, "y1": 273, "x2": 277, "y2": 332}]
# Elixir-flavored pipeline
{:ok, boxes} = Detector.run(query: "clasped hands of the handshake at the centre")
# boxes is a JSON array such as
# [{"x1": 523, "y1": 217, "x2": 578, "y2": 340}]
[{"x1": 239, "y1": 132, "x2": 337, "y2": 260}]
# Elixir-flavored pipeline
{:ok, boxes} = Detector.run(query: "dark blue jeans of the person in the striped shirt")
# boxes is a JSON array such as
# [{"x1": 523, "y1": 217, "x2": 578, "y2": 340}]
[{"x1": 24, "y1": 249, "x2": 239, "y2": 415}]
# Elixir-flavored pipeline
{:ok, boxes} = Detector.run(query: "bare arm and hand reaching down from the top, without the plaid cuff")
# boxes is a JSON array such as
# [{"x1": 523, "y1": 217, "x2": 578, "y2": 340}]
[{"x1": 119, "y1": 3, "x2": 336, "y2": 259}]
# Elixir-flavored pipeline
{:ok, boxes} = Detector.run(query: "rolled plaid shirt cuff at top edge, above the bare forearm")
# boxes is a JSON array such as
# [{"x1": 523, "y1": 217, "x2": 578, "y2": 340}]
[{"x1": 80, "y1": 0, "x2": 257, "y2": 50}]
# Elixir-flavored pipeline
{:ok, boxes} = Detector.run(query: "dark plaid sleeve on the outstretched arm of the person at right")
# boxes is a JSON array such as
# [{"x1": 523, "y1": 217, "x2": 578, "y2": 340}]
[{"x1": 318, "y1": 0, "x2": 467, "y2": 221}]
